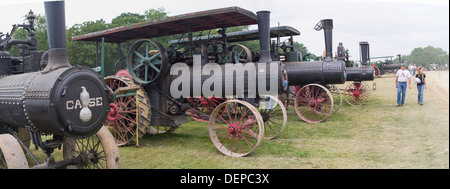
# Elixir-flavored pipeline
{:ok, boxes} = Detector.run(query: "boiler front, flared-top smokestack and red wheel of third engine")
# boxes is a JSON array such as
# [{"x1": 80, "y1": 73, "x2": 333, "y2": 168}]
[{"x1": 286, "y1": 19, "x2": 346, "y2": 123}]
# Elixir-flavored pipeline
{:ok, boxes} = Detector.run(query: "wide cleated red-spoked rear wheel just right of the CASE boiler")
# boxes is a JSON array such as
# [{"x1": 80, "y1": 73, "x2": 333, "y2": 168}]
[{"x1": 105, "y1": 76, "x2": 151, "y2": 146}]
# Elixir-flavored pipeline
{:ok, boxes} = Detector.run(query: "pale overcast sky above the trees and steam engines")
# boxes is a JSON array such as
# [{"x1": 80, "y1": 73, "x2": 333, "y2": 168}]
[{"x1": 0, "y1": 0, "x2": 449, "y2": 60}]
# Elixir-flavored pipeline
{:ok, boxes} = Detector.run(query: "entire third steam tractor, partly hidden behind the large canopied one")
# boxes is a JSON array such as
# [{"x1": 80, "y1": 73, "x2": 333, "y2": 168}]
[{"x1": 169, "y1": 19, "x2": 345, "y2": 123}]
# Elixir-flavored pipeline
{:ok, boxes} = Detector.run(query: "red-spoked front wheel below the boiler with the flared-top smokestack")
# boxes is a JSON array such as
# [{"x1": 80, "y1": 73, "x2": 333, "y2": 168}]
[{"x1": 294, "y1": 84, "x2": 334, "y2": 123}]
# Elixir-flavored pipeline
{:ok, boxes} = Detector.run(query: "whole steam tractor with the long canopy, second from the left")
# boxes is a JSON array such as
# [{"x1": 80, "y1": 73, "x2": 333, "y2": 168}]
[{"x1": 73, "y1": 7, "x2": 287, "y2": 156}]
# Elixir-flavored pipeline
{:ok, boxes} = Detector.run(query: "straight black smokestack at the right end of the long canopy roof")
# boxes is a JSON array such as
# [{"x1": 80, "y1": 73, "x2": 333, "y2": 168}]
[{"x1": 256, "y1": 11, "x2": 272, "y2": 63}]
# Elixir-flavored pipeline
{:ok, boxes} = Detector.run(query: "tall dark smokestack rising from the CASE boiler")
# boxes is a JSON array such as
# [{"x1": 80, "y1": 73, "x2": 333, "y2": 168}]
[{"x1": 44, "y1": 1, "x2": 71, "y2": 72}]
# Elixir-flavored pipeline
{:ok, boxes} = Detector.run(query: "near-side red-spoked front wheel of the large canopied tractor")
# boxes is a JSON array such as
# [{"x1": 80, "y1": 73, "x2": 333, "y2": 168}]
[{"x1": 208, "y1": 100, "x2": 264, "y2": 157}]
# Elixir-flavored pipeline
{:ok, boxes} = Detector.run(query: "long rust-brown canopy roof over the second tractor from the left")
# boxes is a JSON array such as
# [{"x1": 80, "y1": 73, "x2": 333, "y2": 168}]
[{"x1": 72, "y1": 7, "x2": 258, "y2": 43}]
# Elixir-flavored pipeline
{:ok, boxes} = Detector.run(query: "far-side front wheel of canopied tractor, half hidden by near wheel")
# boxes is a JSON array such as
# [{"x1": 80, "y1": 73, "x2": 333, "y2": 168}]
[{"x1": 257, "y1": 96, "x2": 287, "y2": 140}]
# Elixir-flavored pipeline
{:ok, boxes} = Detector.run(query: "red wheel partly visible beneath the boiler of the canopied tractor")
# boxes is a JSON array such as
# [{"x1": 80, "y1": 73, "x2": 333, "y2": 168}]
[{"x1": 186, "y1": 96, "x2": 227, "y2": 122}]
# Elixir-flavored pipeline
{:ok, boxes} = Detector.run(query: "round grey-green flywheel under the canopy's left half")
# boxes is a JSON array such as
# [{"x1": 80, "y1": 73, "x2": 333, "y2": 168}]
[{"x1": 126, "y1": 39, "x2": 169, "y2": 84}]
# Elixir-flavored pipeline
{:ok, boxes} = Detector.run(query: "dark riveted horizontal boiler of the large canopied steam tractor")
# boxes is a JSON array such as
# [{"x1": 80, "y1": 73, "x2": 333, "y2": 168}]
[{"x1": 169, "y1": 62, "x2": 284, "y2": 97}]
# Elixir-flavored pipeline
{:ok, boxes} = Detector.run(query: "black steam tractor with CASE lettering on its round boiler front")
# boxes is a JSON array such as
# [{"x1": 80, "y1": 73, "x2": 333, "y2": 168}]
[{"x1": 0, "y1": 1, "x2": 120, "y2": 169}]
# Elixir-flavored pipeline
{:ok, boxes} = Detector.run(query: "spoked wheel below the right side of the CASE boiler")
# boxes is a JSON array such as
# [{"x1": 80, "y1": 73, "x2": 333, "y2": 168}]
[{"x1": 63, "y1": 127, "x2": 120, "y2": 169}]
